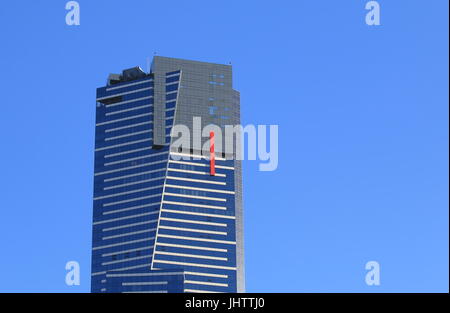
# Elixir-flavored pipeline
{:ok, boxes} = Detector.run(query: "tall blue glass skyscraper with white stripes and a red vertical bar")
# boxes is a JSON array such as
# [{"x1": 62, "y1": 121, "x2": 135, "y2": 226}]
[{"x1": 91, "y1": 56, "x2": 245, "y2": 292}]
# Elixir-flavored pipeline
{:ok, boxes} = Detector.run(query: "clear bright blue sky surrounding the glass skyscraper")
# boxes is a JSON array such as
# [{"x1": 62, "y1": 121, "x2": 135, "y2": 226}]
[{"x1": 0, "y1": 0, "x2": 449, "y2": 292}]
